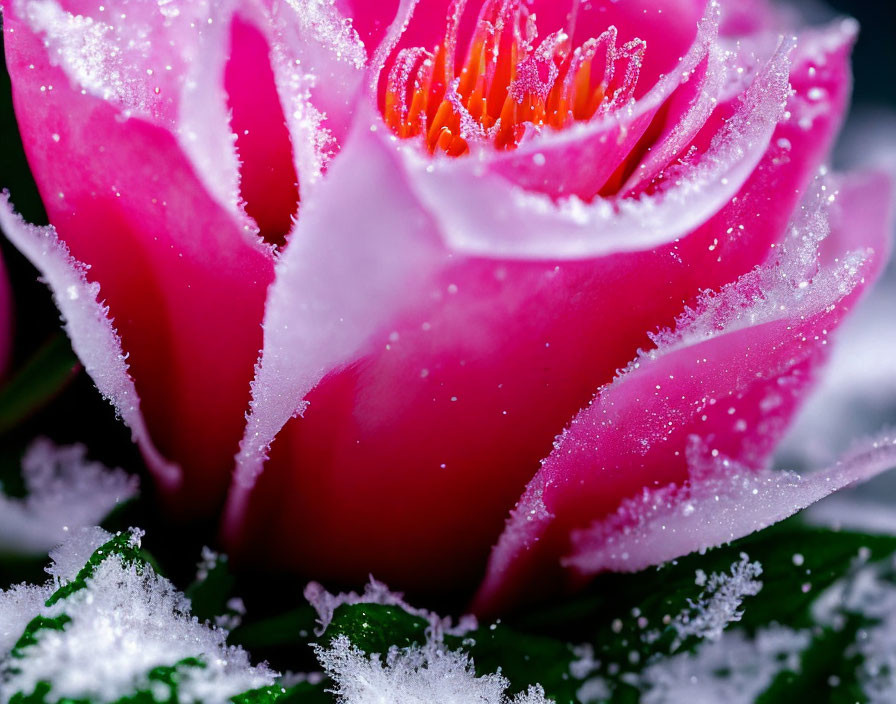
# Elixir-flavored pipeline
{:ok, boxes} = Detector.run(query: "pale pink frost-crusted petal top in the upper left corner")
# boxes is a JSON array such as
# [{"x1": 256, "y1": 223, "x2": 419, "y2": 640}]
[{"x1": 3, "y1": 0, "x2": 248, "y2": 224}]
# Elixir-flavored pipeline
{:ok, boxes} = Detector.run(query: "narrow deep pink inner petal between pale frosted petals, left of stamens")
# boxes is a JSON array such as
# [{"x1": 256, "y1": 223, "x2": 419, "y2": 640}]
[{"x1": 224, "y1": 16, "x2": 299, "y2": 245}]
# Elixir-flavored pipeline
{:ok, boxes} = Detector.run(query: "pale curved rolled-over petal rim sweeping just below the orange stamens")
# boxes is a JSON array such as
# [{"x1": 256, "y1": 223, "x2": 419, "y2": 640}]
[{"x1": 403, "y1": 34, "x2": 788, "y2": 259}]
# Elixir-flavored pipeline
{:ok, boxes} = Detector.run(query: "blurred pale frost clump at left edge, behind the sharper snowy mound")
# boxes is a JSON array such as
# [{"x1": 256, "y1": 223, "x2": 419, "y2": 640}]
[{"x1": 0, "y1": 440, "x2": 137, "y2": 564}]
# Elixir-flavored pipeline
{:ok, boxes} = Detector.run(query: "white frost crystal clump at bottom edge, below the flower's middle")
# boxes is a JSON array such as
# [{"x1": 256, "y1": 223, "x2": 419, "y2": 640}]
[{"x1": 317, "y1": 636, "x2": 549, "y2": 704}]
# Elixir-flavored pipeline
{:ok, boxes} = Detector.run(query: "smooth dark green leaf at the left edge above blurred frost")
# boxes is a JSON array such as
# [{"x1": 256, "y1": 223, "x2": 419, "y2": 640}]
[{"x1": 0, "y1": 333, "x2": 78, "y2": 433}]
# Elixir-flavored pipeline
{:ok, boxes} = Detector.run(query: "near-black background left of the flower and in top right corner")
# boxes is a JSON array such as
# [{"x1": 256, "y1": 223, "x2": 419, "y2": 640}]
[{"x1": 0, "y1": 0, "x2": 896, "y2": 594}]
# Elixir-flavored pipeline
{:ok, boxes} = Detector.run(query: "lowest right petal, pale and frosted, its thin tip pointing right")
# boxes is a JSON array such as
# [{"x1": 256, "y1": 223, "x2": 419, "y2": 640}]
[{"x1": 563, "y1": 428, "x2": 896, "y2": 576}]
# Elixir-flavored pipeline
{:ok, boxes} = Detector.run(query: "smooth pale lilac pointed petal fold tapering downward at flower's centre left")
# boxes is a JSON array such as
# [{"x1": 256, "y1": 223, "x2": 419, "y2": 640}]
[{"x1": 226, "y1": 118, "x2": 442, "y2": 539}]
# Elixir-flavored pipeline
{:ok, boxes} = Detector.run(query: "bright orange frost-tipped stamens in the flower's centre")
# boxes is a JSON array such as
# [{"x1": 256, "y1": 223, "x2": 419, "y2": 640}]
[{"x1": 382, "y1": 0, "x2": 646, "y2": 156}]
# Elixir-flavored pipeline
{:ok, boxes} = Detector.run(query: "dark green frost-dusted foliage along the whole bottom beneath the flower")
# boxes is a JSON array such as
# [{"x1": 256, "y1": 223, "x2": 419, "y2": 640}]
[{"x1": 7, "y1": 520, "x2": 896, "y2": 704}]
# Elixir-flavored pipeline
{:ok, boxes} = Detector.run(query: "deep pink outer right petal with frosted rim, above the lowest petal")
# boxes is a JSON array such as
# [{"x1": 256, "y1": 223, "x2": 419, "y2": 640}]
[{"x1": 476, "y1": 168, "x2": 890, "y2": 611}]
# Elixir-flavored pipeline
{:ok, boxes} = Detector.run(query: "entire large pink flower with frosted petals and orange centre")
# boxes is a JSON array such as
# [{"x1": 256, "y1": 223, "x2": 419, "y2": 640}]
[{"x1": 0, "y1": 0, "x2": 890, "y2": 611}]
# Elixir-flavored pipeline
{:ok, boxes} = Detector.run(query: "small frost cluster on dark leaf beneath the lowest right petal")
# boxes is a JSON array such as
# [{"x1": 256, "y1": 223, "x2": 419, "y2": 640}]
[{"x1": 672, "y1": 553, "x2": 762, "y2": 640}]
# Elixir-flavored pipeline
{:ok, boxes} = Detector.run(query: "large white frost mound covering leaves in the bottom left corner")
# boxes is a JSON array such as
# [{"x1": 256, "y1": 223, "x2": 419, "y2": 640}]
[{"x1": 0, "y1": 531, "x2": 274, "y2": 704}]
